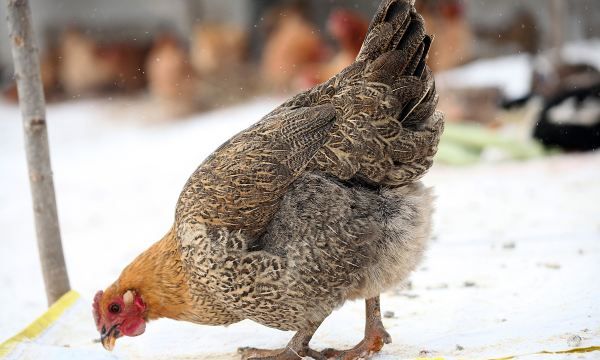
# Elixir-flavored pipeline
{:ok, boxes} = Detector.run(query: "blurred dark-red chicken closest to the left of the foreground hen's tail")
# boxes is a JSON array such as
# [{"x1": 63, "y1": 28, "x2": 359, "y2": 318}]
[{"x1": 296, "y1": 9, "x2": 369, "y2": 89}]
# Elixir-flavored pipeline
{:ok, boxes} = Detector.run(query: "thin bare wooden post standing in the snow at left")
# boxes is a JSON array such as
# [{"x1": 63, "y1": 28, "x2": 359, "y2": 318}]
[{"x1": 6, "y1": 0, "x2": 70, "y2": 305}]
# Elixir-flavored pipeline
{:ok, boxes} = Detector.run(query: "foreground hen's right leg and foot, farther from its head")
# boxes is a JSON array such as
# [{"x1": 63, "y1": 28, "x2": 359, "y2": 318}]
[{"x1": 321, "y1": 296, "x2": 392, "y2": 360}]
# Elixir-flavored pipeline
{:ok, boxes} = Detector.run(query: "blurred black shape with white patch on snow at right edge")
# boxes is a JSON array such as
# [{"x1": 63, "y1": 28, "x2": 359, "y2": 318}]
[{"x1": 533, "y1": 82, "x2": 600, "y2": 151}]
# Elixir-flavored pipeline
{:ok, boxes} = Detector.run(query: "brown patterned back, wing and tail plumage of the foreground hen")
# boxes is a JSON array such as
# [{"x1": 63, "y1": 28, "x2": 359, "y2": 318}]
[{"x1": 177, "y1": 1, "x2": 443, "y2": 235}]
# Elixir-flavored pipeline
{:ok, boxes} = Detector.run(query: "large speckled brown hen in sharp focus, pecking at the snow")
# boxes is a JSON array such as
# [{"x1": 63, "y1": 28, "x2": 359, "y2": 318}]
[{"x1": 93, "y1": 0, "x2": 443, "y2": 359}]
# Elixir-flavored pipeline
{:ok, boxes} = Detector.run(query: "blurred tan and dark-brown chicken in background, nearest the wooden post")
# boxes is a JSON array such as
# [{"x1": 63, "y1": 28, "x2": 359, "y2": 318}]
[{"x1": 59, "y1": 29, "x2": 147, "y2": 96}]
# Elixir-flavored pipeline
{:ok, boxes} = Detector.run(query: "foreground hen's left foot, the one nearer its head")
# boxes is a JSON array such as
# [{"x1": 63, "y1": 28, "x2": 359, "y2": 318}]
[{"x1": 238, "y1": 326, "x2": 326, "y2": 360}]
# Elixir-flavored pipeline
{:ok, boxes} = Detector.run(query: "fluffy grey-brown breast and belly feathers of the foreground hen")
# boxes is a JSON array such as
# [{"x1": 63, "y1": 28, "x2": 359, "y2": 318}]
[{"x1": 178, "y1": 173, "x2": 431, "y2": 331}]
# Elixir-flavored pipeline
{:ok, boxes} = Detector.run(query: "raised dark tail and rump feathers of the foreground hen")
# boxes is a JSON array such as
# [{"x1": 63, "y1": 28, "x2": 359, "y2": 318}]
[{"x1": 304, "y1": 0, "x2": 443, "y2": 186}]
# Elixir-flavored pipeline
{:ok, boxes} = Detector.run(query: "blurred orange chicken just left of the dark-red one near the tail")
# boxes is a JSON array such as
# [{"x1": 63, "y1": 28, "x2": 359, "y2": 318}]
[{"x1": 261, "y1": 8, "x2": 330, "y2": 90}]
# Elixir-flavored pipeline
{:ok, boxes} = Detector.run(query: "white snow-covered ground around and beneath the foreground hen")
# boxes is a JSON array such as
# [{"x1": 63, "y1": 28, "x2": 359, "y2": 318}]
[{"x1": 0, "y1": 95, "x2": 600, "y2": 359}]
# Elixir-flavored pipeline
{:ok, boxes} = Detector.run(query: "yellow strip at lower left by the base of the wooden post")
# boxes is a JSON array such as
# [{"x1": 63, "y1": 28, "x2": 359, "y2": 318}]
[{"x1": 0, "y1": 290, "x2": 80, "y2": 357}]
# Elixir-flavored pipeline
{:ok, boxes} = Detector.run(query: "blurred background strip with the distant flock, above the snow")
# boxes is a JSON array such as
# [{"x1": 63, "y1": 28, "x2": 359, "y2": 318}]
[{"x1": 0, "y1": 0, "x2": 600, "y2": 141}]
